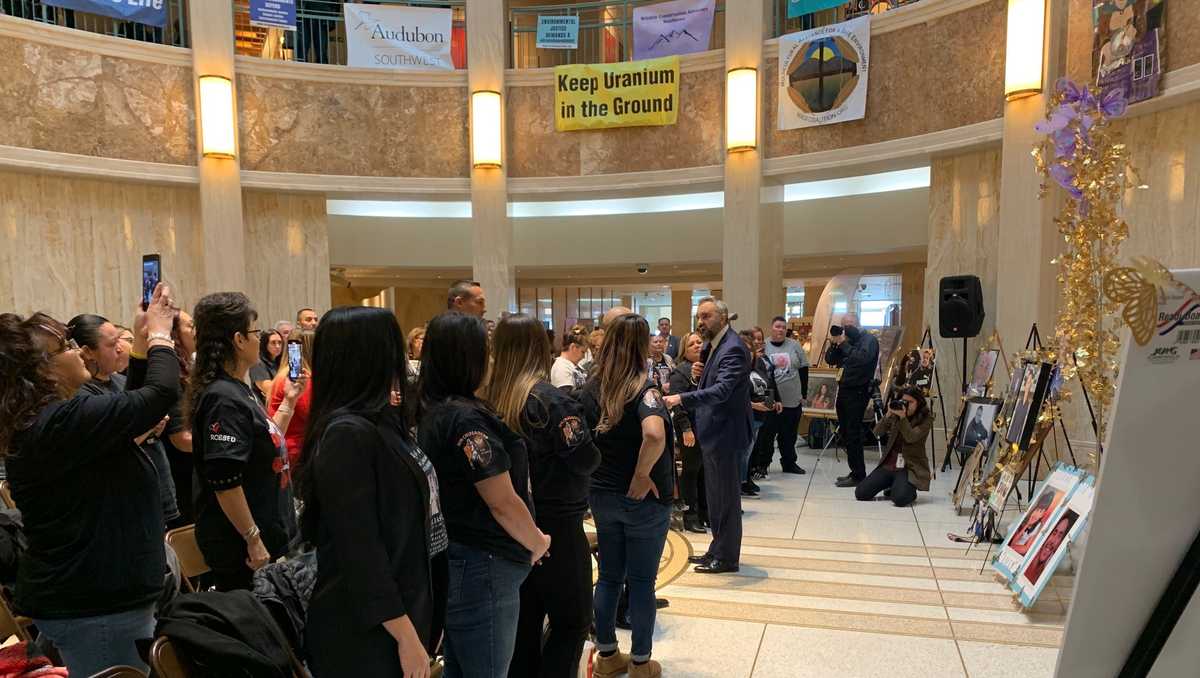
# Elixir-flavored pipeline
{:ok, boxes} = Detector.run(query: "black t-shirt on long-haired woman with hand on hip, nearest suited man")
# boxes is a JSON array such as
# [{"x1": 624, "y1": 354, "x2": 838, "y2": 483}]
[{"x1": 580, "y1": 379, "x2": 674, "y2": 504}]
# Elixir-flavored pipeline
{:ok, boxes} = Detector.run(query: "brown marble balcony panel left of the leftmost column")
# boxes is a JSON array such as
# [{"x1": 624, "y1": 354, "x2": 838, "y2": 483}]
[{"x1": 0, "y1": 35, "x2": 196, "y2": 164}]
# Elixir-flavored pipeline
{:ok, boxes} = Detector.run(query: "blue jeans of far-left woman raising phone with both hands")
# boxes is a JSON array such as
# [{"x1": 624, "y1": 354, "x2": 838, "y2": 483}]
[{"x1": 34, "y1": 605, "x2": 154, "y2": 676}]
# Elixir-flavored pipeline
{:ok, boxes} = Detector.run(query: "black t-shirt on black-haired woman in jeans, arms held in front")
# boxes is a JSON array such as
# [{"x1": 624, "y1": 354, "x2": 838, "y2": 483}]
[{"x1": 418, "y1": 398, "x2": 533, "y2": 563}]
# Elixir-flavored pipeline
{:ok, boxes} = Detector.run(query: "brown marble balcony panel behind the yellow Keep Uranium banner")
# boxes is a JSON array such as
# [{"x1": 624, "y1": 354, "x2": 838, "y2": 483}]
[{"x1": 506, "y1": 68, "x2": 725, "y2": 176}]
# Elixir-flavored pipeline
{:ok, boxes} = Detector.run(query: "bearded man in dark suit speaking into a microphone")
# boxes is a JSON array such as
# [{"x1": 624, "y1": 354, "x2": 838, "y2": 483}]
[{"x1": 665, "y1": 296, "x2": 752, "y2": 574}]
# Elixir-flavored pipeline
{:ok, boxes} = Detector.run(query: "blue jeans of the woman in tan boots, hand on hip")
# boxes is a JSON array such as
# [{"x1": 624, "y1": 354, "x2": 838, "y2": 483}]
[{"x1": 592, "y1": 492, "x2": 671, "y2": 661}]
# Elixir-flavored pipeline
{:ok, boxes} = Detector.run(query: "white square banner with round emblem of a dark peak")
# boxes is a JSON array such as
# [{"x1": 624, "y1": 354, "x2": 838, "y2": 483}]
[{"x1": 778, "y1": 17, "x2": 871, "y2": 130}]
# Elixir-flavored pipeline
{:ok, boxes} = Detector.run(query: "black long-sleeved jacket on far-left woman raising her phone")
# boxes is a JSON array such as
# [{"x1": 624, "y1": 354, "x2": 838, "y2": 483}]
[{"x1": 6, "y1": 347, "x2": 179, "y2": 619}]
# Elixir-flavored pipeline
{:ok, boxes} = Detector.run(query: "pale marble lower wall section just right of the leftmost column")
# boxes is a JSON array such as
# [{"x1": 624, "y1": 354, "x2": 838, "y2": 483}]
[{"x1": 241, "y1": 191, "x2": 330, "y2": 326}]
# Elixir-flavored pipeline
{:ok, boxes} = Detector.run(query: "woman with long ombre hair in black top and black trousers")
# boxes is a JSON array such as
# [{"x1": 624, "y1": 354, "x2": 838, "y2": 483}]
[{"x1": 486, "y1": 313, "x2": 600, "y2": 678}]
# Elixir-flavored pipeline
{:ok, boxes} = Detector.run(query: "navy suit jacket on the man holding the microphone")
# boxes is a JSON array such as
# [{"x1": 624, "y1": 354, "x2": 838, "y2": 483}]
[{"x1": 679, "y1": 328, "x2": 752, "y2": 454}]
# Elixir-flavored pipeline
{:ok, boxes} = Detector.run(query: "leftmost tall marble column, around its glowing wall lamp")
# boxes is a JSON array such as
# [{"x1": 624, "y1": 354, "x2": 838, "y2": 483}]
[{"x1": 187, "y1": 0, "x2": 246, "y2": 294}]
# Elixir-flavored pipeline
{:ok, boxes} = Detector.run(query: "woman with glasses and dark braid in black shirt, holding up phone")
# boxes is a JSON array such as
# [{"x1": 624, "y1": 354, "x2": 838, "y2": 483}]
[{"x1": 184, "y1": 292, "x2": 304, "y2": 590}]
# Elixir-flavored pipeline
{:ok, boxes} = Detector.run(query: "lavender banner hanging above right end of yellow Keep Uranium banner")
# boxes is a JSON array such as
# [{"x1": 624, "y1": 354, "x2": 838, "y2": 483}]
[{"x1": 634, "y1": 0, "x2": 716, "y2": 59}]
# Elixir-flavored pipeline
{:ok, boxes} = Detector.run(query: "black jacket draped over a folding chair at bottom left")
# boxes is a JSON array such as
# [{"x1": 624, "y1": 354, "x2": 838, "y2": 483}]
[{"x1": 154, "y1": 590, "x2": 293, "y2": 678}]
